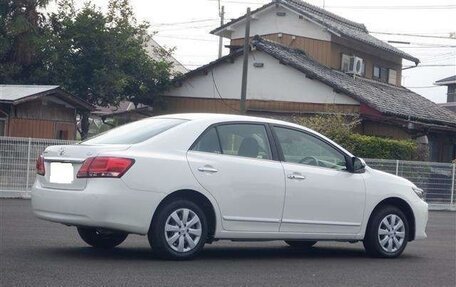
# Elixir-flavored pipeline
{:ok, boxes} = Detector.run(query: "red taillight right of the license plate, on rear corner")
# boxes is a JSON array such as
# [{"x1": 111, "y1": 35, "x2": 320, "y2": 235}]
[{"x1": 77, "y1": 156, "x2": 135, "y2": 178}]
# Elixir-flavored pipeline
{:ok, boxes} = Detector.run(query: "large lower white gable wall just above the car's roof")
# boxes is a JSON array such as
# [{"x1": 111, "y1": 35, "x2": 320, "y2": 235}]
[{"x1": 167, "y1": 51, "x2": 359, "y2": 105}]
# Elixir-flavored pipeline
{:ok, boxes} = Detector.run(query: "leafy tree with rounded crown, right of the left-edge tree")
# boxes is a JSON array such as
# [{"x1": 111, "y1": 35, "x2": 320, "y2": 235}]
[{"x1": 47, "y1": 0, "x2": 171, "y2": 138}]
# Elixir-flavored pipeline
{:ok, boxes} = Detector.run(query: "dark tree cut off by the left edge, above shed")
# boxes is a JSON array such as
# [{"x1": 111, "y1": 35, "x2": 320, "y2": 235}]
[{"x1": 0, "y1": 0, "x2": 49, "y2": 83}]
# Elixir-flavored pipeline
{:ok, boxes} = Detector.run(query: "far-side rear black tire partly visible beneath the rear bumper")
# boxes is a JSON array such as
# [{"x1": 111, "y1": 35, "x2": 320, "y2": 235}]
[{"x1": 78, "y1": 227, "x2": 128, "y2": 249}]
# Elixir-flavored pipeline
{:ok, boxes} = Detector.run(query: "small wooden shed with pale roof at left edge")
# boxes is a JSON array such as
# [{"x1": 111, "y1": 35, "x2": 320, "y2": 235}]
[{"x1": 0, "y1": 85, "x2": 93, "y2": 140}]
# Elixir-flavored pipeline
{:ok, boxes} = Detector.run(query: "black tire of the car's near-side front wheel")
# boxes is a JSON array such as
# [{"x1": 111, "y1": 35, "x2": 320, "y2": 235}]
[{"x1": 363, "y1": 205, "x2": 409, "y2": 258}]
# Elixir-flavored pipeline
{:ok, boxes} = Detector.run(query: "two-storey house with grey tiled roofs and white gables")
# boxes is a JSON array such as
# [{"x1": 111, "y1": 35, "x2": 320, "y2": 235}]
[{"x1": 158, "y1": 0, "x2": 456, "y2": 161}]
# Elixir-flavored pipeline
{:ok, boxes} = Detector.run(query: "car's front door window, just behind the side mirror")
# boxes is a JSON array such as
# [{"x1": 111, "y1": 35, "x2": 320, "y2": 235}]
[{"x1": 274, "y1": 127, "x2": 346, "y2": 170}]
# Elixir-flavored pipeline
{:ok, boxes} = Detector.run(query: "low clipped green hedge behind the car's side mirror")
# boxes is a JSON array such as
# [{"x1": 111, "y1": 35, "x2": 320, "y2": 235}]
[{"x1": 339, "y1": 134, "x2": 418, "y2": 160}]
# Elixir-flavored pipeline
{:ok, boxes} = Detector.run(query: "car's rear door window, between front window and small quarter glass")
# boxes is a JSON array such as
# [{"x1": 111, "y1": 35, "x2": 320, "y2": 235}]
[{"x1": 217, "y1": 124, "x2": 272, "y2": 159}]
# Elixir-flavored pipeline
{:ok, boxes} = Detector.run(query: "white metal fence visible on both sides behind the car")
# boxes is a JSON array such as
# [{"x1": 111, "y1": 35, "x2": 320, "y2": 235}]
[{"x1": 0, "y1": 137, "x2": 456, "y2": 208}]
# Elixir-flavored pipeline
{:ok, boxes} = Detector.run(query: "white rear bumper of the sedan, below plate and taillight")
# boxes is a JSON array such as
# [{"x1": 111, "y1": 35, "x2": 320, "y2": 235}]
[{"x1": 31, "y1": 178, "x2": 164, "y2": 234}]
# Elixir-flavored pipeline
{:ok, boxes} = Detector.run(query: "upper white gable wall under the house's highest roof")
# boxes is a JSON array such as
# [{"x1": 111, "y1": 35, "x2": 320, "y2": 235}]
[{"x1": 230, "y1": 7, "x2": 331, "y2": 41}]
